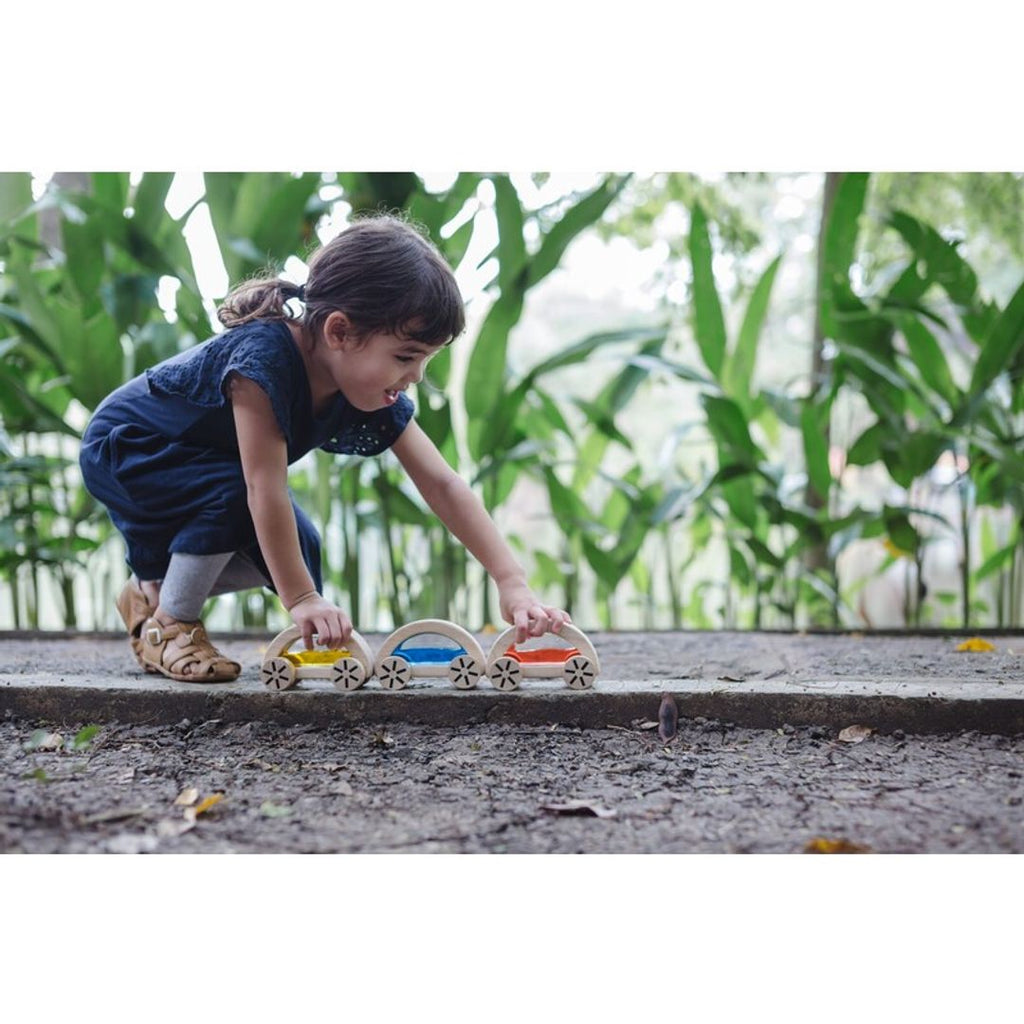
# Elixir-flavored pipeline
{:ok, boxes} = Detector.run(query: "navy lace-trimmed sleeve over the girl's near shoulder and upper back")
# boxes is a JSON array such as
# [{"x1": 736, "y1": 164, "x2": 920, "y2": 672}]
[{"x1": 146, "y1": 322, "x2": 298, "y2": 442}]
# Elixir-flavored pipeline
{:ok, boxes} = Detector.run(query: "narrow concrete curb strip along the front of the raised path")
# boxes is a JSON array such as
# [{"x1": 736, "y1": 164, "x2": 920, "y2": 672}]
[{"x1": 8, "y1": 677, "x2": 1024, "y2": 734}]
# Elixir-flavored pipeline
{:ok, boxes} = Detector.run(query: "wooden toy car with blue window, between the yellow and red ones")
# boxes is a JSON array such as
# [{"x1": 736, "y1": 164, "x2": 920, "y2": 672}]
[{"x1": 374, "y1": 618, "x2": 486, "y2": 690}]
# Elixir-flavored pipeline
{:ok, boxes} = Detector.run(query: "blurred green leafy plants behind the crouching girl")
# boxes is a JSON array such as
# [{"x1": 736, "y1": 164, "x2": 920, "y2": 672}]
[{"x1": 0, "y1": 172, "x2": 1024, "y2": 629}]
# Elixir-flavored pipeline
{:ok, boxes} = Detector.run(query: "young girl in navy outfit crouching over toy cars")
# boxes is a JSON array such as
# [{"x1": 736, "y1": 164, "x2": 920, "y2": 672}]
[{"x1": 81, "y1": 216, "x2": 569, "y2": 682}]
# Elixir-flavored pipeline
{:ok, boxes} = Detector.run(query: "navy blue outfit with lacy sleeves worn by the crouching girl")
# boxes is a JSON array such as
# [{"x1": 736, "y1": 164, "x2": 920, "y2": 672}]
[{"x1": 79, "y1": 321, "x2": 413, "y2": 590}]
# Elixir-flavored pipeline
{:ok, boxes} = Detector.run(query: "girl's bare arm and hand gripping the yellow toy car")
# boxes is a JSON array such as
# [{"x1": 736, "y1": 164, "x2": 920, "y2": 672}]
[{"x1": 228, "y1": 375, "x2": 352, "y2": 647}]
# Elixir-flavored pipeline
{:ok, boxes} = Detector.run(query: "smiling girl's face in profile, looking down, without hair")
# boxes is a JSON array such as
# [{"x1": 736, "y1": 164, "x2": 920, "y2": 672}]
[{"x1": 331, "y1": 325, "x2": 441, "y2": 413}]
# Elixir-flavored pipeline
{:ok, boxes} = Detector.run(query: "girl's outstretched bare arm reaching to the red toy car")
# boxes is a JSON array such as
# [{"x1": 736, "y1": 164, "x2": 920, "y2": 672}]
[{"x1": 392, "y1": 420, "x2": 571, "y2": 643}]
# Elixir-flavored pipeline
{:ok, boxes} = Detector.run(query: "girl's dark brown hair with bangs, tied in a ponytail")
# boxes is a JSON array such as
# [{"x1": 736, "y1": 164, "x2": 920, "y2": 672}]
[{"x1": 217, "y1": 214, "x2": 466, "y2": 345}]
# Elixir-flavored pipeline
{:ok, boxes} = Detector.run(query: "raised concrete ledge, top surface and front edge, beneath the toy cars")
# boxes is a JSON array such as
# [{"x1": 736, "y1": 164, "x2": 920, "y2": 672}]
[{"x1": 8, "y1": 633, "x2": 1024, "y2": 735}]
